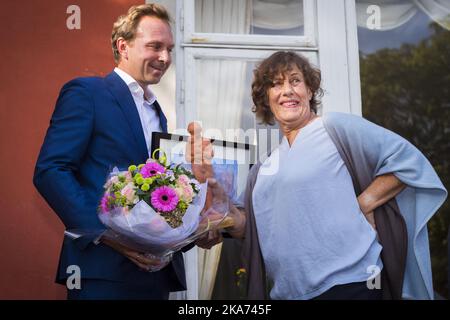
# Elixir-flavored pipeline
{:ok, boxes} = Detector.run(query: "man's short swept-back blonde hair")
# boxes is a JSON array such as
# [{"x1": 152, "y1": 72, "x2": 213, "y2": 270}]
[{"x1": 111, "y1": 3, "x2": 171, "y2": 63}]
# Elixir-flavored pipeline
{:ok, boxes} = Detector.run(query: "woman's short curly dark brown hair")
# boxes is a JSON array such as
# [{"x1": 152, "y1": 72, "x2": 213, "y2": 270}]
[{"x1": 252, "y1": 51, "x2": 323, "y2": 125}]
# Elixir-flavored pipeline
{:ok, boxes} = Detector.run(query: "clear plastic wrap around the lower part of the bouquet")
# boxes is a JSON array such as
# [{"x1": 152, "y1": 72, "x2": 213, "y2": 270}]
[{"x1": 99, "y1": 183, "x2": 229, "y2": 258}]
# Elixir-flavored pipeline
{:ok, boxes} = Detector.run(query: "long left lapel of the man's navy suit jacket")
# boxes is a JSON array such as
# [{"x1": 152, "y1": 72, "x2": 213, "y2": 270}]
[{"x1": 105, "y1": 71, "x2": 148, "y2": 160}]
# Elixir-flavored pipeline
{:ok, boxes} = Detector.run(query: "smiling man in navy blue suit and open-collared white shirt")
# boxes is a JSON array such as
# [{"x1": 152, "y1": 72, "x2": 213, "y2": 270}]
[{"x1": 33, "y1": 4, "x2": 186, "y2": 299}]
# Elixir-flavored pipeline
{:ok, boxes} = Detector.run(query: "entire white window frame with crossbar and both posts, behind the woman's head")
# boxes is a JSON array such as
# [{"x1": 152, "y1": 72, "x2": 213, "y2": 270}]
[{"x1": 175, "y1": 0, "x2": 361, "y2": 299}]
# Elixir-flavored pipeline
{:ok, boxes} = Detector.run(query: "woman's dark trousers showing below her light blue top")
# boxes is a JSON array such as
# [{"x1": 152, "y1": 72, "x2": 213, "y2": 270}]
[{"x1": 313, "y1": 281, "x2": 382, "y2": 300}]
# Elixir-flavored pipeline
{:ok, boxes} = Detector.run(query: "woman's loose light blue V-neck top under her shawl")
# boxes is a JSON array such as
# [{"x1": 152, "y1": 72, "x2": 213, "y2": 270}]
[{"x1": 253, "y1": 118, "x2": 382, "y2": 299}]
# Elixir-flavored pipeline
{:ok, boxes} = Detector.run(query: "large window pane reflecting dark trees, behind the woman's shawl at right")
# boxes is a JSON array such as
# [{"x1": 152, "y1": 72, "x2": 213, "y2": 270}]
[{"x1": 356, "y1": 1, "x2": 450, "y2": 296}]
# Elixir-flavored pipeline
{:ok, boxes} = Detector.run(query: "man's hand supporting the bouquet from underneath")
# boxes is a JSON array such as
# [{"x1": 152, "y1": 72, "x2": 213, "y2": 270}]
[{"x1": 100, "y1": 237, "x2": 171, "y2": 272}]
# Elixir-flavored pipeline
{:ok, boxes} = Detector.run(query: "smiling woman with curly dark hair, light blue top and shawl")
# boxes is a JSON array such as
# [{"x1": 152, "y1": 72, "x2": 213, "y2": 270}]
[{"x1": 193, "y1": 51, "x2": 447, "y2": 299}]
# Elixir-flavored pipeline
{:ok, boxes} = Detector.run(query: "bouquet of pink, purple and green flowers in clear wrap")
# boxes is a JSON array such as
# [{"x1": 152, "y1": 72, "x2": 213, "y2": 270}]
[{"x1": 99, "y1": 150, "x2": 228, "y2": 257}]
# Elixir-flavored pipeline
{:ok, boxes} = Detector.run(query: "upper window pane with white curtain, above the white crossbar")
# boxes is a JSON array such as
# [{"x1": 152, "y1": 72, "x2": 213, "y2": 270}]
[{"x1": 195, "y1": 0, "x2": 304, "y2": 36}]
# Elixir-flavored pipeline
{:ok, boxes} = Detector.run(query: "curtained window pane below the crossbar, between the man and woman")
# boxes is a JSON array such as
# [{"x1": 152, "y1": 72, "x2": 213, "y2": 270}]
[{"x1": 195, "y1": 58, "x2": 255, "y2": 300}]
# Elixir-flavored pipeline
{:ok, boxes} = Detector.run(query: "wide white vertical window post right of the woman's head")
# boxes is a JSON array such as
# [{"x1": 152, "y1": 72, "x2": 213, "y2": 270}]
[{"x1": 317, "y1": 0, "x2": 362, "y2": 115}]
